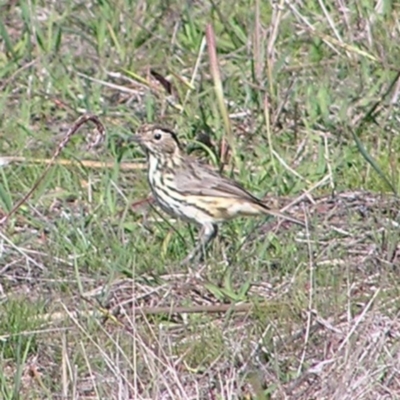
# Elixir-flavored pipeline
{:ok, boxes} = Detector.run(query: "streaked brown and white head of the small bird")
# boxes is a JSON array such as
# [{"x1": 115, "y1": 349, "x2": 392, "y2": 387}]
[{"x1": 131, "y1": 125, "x2": 181, "y2": 159}]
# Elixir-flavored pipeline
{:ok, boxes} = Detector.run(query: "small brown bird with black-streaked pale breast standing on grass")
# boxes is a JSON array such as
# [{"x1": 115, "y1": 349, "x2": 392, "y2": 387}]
[{"x1": 129, "y1": 124, "x2": 305, "y2": 264}]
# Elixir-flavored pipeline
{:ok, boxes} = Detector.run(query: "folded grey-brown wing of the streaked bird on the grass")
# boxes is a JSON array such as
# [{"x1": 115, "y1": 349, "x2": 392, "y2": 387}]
[{"x1": 175, "y1": 162, "x2": 260, "y2": 203}]
